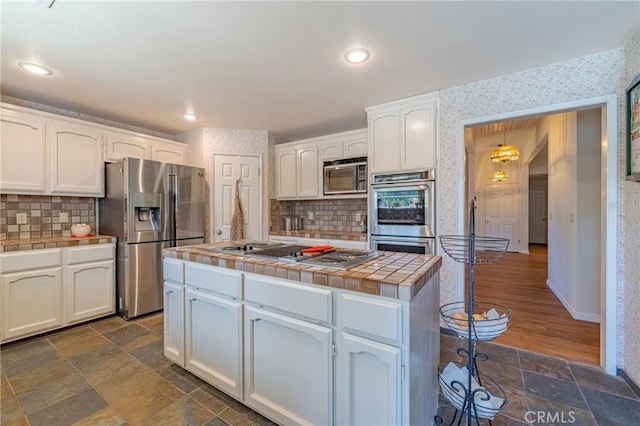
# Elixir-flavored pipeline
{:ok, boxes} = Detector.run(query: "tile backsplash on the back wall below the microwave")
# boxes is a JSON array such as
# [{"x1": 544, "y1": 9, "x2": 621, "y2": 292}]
[{"x1": 270, "y1": 198, "x2": 367, "y2": 232}]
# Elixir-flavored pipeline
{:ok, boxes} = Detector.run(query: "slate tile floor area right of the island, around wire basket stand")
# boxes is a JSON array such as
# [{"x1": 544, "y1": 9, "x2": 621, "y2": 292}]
[{"x1": 438, "y1": 335, "x2": 640, "y2": 426}]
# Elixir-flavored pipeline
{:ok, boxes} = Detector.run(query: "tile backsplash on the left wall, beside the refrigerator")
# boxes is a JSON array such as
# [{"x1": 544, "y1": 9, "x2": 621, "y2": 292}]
[{"x1": 0, "y1": 194, "x2": 96, "y2": 240}]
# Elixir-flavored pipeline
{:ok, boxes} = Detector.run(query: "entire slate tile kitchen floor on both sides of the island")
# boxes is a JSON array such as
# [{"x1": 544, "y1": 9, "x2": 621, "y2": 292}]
[{"x1": 0, "y1": 314, "x2": 640, "y2": 426}]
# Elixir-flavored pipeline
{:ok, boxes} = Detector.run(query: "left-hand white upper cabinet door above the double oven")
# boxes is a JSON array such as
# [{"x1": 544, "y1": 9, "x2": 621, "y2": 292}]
[{"x1": 369, "y1": 113, "x2": 399, "y2": 172}]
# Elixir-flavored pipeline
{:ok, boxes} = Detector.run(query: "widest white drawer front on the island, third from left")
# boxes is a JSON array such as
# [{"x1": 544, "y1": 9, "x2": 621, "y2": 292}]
[{"x1": 244, "y1": 274, "x2": 331, "y2": 323}]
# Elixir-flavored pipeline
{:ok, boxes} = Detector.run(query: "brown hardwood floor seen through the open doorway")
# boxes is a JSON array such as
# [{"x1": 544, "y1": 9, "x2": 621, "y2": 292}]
[{"x1": 475, "y1": 244, "x2": 600, "y2": 365}]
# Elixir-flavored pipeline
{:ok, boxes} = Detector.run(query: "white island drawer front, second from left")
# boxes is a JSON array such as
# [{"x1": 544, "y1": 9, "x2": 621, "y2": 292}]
[{"x1": 184, "y1": 263, "x2": 243, "y2": 299}]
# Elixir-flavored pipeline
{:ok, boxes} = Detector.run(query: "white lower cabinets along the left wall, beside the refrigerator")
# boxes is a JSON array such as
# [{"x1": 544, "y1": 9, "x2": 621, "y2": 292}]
[{"x1": 0, "y1": 244, "x2": 115, "y2": 343}]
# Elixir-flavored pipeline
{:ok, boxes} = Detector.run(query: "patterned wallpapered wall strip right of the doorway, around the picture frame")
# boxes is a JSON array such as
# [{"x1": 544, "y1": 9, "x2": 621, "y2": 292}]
[{"x1": 618, "y1": 32, "x2": 640, "y2": 383}]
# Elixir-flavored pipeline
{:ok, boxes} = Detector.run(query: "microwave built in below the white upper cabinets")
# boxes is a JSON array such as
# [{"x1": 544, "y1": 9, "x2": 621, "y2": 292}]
[{"x1": 323, "y1": 157, "x2": 367, "y2": 195}]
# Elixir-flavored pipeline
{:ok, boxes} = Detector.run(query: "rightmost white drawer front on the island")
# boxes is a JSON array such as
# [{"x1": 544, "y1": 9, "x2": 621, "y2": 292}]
[{"x1": 340, "y1": 293, "x2": 402, "y2": 343}]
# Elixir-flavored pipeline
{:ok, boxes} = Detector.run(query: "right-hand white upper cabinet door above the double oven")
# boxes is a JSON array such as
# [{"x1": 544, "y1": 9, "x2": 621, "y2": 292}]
[{"x1": 400, "y1": 103, "x2": 436, "y2": 170}]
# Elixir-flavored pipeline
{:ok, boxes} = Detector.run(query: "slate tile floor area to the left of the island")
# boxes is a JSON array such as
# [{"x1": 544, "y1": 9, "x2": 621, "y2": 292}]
[{"x1": 0, "y1": 314, "x2": 273, "y2": 426}]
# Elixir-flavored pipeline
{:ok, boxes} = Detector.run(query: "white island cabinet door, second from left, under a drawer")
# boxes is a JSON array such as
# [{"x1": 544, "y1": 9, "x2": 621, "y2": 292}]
[{"x1": 185, "y1": 287, "x2": 242, "y2": 398}]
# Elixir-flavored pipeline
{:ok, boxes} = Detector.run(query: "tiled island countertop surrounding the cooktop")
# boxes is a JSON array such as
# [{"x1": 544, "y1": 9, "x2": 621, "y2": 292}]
[{"x1": 164, "y1": 240, "x2": 442, "y2": 300}]
